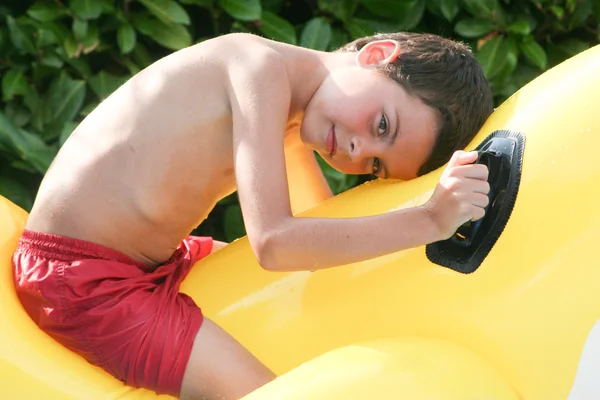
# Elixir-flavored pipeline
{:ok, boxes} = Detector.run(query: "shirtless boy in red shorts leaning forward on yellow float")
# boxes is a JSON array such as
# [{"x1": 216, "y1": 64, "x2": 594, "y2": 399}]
[{"x1": 13, "y1": 34, "x2": 492, "y2": 399}]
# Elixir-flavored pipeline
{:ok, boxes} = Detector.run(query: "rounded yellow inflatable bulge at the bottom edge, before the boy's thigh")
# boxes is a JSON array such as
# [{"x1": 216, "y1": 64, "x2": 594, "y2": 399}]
[{"x1": 244, "y1": 338, "x2": 519, "y2": 400}]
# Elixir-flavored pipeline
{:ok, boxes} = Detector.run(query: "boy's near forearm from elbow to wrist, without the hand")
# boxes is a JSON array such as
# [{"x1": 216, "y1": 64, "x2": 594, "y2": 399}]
[{"x1": 258, "y1": 207, "x2": 441, "y2": 271}]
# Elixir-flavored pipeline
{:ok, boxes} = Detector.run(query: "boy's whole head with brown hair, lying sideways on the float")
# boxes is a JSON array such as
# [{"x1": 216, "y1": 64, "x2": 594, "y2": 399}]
[{"x1": 302, "y1": 33, "x2": 493, "y2": 179}]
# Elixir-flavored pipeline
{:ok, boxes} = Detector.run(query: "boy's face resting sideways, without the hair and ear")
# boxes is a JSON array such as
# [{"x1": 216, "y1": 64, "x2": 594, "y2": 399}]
[{"x1": 301, "y1": 66, "x2": 438, "y2": 180}]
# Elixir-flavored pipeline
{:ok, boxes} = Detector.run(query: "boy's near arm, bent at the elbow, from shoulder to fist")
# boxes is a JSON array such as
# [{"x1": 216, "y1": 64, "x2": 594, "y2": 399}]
[{"x1": 229, "y1": 54, "x2": 489, "y2": 271}]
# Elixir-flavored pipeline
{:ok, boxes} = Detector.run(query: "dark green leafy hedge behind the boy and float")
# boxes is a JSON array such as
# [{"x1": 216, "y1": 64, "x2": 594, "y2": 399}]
[{"x1": 0, "y1": 0, "x2": 600, "y2": 241}]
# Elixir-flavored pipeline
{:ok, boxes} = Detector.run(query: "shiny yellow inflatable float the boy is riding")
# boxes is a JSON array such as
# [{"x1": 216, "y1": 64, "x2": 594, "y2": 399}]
[{"x1": 0, "y1": 42, "x2": 600, "y2": 400}]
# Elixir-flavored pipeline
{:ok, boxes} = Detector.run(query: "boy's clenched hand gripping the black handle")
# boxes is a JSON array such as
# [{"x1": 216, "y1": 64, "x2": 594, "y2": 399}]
[{"x1": 425, "y1": 151, "x2": 490, "y2": 240}]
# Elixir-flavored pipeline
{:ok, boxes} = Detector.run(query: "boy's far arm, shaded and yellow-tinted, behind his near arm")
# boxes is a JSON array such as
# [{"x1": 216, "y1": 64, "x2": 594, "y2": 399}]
[{"x1": 285, "y1": 131, "x2": 333, "y2": 214}]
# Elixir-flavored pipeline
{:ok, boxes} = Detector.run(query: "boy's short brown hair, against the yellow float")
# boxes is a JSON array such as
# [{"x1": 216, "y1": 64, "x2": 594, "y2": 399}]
[{"x1": 338, "y1": 32, "x2": 493, "y2": 175}]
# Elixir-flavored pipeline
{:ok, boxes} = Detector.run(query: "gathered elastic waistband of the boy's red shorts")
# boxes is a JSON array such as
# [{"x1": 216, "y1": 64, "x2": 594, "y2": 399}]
[{"x1": 17, "y1": 229, "x2": 151, "y2": 270}]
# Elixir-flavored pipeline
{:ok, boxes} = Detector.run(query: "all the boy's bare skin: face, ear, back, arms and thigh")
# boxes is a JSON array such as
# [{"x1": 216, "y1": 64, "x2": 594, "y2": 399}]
[{"x1": 27, "y1": 34, "x2": 489, "y2": 399}]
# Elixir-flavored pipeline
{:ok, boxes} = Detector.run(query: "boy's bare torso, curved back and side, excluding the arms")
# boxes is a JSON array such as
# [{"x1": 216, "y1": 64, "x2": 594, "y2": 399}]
[{"x1": 27, "y1": 33, "x2": 298, "y2": 265}]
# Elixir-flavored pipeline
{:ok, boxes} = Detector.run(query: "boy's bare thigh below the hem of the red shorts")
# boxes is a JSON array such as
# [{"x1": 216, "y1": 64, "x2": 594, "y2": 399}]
[{"x1": 180, "y1": 317, "x2": 275, "y2": 400}]
